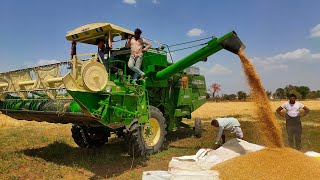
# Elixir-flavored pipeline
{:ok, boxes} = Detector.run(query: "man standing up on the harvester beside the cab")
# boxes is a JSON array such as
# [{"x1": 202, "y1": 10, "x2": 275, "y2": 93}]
[{"x1": 126, "y1": 29, "x2": 151, "y2": 83}]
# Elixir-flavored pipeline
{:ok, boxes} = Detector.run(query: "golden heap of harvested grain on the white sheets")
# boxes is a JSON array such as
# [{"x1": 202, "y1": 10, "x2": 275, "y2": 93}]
[{"x1": 212, "y1": 148, "x2": 320, "y2": 179}]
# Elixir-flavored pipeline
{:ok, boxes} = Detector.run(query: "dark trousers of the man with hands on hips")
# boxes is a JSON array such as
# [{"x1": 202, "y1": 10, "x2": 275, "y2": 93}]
[{"x1": 286, "y1": 116, "x2": 302, "y2": 150}]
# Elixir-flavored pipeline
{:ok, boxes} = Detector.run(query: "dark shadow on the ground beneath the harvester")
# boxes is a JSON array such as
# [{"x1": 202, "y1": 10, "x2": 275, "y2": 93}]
[{"x1": 22, "y1": 139, "x2": 145, "y2": 179}]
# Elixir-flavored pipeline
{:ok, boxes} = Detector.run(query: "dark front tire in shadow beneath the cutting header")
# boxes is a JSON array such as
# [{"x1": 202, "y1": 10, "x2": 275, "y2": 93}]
[{"x1": 71, "y1": 125, "x2": 110, "y2": 149}]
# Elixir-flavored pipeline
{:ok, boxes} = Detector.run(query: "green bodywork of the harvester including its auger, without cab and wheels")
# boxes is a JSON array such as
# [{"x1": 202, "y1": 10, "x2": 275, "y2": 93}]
[{"x1": 0, "y1": 32, "x2": 242, "y2": 131}]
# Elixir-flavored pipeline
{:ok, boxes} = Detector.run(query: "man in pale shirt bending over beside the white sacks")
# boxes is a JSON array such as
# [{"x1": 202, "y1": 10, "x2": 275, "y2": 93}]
[{"x1": 211, "y1": 117, "x2": 243, "y2": 149}]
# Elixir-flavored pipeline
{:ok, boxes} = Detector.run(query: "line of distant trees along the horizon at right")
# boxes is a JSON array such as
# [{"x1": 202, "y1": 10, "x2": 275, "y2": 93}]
[{"x1": 207, "y1": 83, "x2": 320, "y2": 101}]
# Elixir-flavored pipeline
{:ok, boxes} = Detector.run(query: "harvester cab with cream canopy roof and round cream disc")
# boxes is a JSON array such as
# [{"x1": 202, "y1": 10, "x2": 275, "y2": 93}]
[{"x1": 66, "y1": 23, "x2": 133, "y2": 92}]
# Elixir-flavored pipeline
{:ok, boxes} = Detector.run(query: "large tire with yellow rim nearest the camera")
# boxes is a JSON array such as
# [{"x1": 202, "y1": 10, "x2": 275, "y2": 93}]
[{"x1": 127, "y1": 106, "x2": 167, "y2": 156}]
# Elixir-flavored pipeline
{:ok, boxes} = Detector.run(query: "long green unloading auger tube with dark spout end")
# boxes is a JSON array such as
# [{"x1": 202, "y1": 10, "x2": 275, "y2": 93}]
[{"x1": 155, "y1": 31, "x2": 245, "y2": 80}]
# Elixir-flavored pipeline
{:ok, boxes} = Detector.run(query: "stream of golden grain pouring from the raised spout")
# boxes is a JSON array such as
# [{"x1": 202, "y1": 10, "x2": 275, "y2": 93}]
[{"x1": 238, "y1": 50, "x2": 283, "y2": 147}]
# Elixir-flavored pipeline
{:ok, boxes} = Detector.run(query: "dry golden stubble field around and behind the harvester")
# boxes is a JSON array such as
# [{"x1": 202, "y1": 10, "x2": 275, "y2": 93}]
[{"x1": 0, "y1": 101, "x2": 320, "y2": 179}]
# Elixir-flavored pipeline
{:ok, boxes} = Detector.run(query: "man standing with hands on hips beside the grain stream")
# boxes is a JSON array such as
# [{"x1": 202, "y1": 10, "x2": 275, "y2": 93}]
[{"x1": 277, "y1": 94, "x2": 310, "y2": 150}]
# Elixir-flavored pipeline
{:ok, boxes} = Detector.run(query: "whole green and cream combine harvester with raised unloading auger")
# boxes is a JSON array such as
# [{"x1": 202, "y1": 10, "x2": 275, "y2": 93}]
[{"x1": 0, "y1": 23, "x2": 244, "y2": 155}]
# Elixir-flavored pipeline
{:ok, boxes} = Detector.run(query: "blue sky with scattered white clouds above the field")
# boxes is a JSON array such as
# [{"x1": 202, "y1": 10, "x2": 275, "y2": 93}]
[{"x1": 0, "y1": 0, "x2": 320, "y2": 93}]
